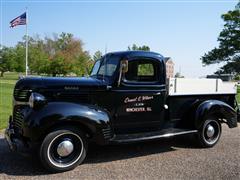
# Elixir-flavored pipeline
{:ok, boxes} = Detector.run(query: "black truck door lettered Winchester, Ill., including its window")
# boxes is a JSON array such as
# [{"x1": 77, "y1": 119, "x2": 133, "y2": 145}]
[{"x1": 113, "y1": 57, "x2": 166, "y2": 134}]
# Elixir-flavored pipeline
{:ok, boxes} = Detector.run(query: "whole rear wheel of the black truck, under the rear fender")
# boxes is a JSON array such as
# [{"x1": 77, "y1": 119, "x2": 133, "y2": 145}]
[{"x1": 198, "y1": 118, "x2": 222, "y2": 147}]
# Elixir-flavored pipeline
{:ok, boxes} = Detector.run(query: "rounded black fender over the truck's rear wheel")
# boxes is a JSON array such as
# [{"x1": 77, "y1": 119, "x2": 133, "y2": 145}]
[{"x1": 195, "y1": 100, "x2": 237, "y2": 129}]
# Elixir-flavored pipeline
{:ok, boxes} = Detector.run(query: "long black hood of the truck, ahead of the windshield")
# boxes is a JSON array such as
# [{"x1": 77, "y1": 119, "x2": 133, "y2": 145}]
[{"x1": 15, "y1": 77, "x2": 106, "y2": 90}]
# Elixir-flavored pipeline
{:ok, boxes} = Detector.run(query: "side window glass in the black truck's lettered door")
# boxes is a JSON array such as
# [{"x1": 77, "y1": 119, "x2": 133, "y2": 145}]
[{"x1": 125, "y1": 59, "x2": 160, "y2": 83}]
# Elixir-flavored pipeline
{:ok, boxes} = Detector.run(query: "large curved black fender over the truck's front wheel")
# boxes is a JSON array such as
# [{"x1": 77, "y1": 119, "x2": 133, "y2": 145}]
[{"x1": 25, "y1": 102, "x2": 110, "y2": 143}]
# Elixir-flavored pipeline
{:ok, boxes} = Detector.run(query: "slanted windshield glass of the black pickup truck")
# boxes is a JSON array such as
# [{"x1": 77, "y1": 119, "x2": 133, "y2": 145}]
[{"x1": 91, "y1": 55, "x2": 119, "y2": 78}]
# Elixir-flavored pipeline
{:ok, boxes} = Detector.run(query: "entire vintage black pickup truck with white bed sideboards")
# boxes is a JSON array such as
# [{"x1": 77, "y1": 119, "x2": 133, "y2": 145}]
[{"x1": 5, "y1": 51, "x2": 238, "y2": 172}]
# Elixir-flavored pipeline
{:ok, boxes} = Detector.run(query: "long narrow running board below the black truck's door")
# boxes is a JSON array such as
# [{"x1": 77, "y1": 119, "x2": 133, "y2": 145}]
[{"x1": 110, "y1": 129, "x2": 198, "y2": 143}]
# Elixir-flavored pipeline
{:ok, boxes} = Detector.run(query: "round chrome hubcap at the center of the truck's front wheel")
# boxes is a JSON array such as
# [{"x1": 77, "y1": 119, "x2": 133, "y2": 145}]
[{"x1": 57, "y1": 140, "x2": 74, "y2": 157}]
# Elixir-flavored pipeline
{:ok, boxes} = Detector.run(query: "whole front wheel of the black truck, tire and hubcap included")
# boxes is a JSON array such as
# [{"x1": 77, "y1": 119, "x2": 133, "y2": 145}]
[{"x1": 40, "y1": 128, "x2": 87, "y2": 172}]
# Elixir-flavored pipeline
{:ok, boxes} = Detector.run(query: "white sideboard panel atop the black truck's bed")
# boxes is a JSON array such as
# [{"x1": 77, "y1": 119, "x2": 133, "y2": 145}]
[{"x1": 168, "y1": 78, "x2": 237, "y2": 96}]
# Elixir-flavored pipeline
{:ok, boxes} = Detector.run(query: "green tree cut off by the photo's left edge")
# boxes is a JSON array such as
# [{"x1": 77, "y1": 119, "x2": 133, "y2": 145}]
[{"x1": 0, "y1": 47, "x2": 15, "y2": 77}]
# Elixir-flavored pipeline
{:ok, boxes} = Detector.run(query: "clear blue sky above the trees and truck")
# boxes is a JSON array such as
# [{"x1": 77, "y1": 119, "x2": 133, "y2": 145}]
[{"x1": 0, "y1": 0, "x2": 238, "y2": 77}]
